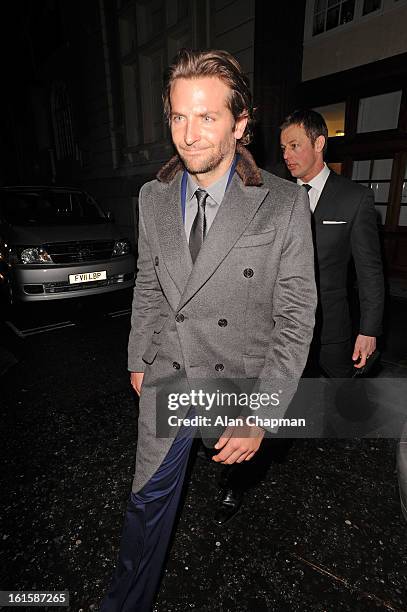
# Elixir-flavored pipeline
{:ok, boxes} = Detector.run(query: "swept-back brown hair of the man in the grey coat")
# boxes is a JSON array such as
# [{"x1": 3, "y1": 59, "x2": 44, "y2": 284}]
[{"x1": 163, "y1": 49, "x2": 254, "y2": 145}]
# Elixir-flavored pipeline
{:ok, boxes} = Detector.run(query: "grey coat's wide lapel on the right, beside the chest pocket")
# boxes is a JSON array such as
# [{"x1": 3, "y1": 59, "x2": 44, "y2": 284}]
[{"x1": 179, "y1": 173, "x2": 268, "y2": 308}]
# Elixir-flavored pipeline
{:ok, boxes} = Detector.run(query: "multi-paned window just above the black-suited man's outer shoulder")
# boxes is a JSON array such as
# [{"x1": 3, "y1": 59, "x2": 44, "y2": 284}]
[{"x1": 352, "y1": 159, "x2": 393, "y2": 225}]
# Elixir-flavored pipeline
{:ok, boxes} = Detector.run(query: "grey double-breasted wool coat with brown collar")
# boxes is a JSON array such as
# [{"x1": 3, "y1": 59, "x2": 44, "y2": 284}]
[{"x1": 128, "y1": 146, "x2": 316, "y2": 492}]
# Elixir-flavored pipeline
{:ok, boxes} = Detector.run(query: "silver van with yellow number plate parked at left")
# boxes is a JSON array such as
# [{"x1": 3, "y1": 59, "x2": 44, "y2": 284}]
[{"x1": 0, "y1": 186, "x2": 135, "y2": 302}]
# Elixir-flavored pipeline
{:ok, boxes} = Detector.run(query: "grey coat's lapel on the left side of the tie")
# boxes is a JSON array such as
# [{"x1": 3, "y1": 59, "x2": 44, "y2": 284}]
[{"x1": 154, "y1": 172, "x2": 192, "y2": 295}]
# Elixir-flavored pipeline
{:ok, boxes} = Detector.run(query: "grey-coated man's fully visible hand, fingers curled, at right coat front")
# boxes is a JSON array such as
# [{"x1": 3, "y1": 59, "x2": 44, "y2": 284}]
[{"x1": 212, "y1": 425, "x2": 265, "y2": 465}]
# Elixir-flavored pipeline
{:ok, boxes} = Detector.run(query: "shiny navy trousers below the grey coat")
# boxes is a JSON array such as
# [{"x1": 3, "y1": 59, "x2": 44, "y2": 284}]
[{"x1": 100, "y1": 420, "x2": 194, "y2": 612}]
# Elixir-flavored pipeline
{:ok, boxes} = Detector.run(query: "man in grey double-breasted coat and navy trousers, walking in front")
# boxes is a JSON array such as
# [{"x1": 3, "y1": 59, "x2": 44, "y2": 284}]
[{"x1": 101, "y1": 50, "x2": 316, "y2": 612}]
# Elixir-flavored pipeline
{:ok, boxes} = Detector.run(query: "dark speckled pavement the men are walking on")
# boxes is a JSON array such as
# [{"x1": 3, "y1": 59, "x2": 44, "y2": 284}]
[{"x1": 0, "y1": 294, "x2": 407, "y2": 612}]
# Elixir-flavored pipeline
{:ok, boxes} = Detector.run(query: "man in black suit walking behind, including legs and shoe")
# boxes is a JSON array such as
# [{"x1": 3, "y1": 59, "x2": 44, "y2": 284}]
[{"x1": 215, "y1": 110, "x2": 384, "y2": 524}]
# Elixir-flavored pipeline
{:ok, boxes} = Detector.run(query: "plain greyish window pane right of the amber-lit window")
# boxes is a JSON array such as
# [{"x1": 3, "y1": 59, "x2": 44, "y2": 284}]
[{"x1": 357, "y1": 91, "x2": 402, "y2": 134}]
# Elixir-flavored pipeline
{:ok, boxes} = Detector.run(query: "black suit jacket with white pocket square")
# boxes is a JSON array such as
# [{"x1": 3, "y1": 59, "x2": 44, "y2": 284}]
[{"x1": 312, "y1": 171, "x2": 384, "y2": 344}]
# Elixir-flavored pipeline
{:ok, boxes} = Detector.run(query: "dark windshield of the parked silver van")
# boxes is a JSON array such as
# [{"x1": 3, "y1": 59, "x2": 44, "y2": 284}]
[{"x1": 0, "y1": 189, "x2": 108, "y2": 225}]
